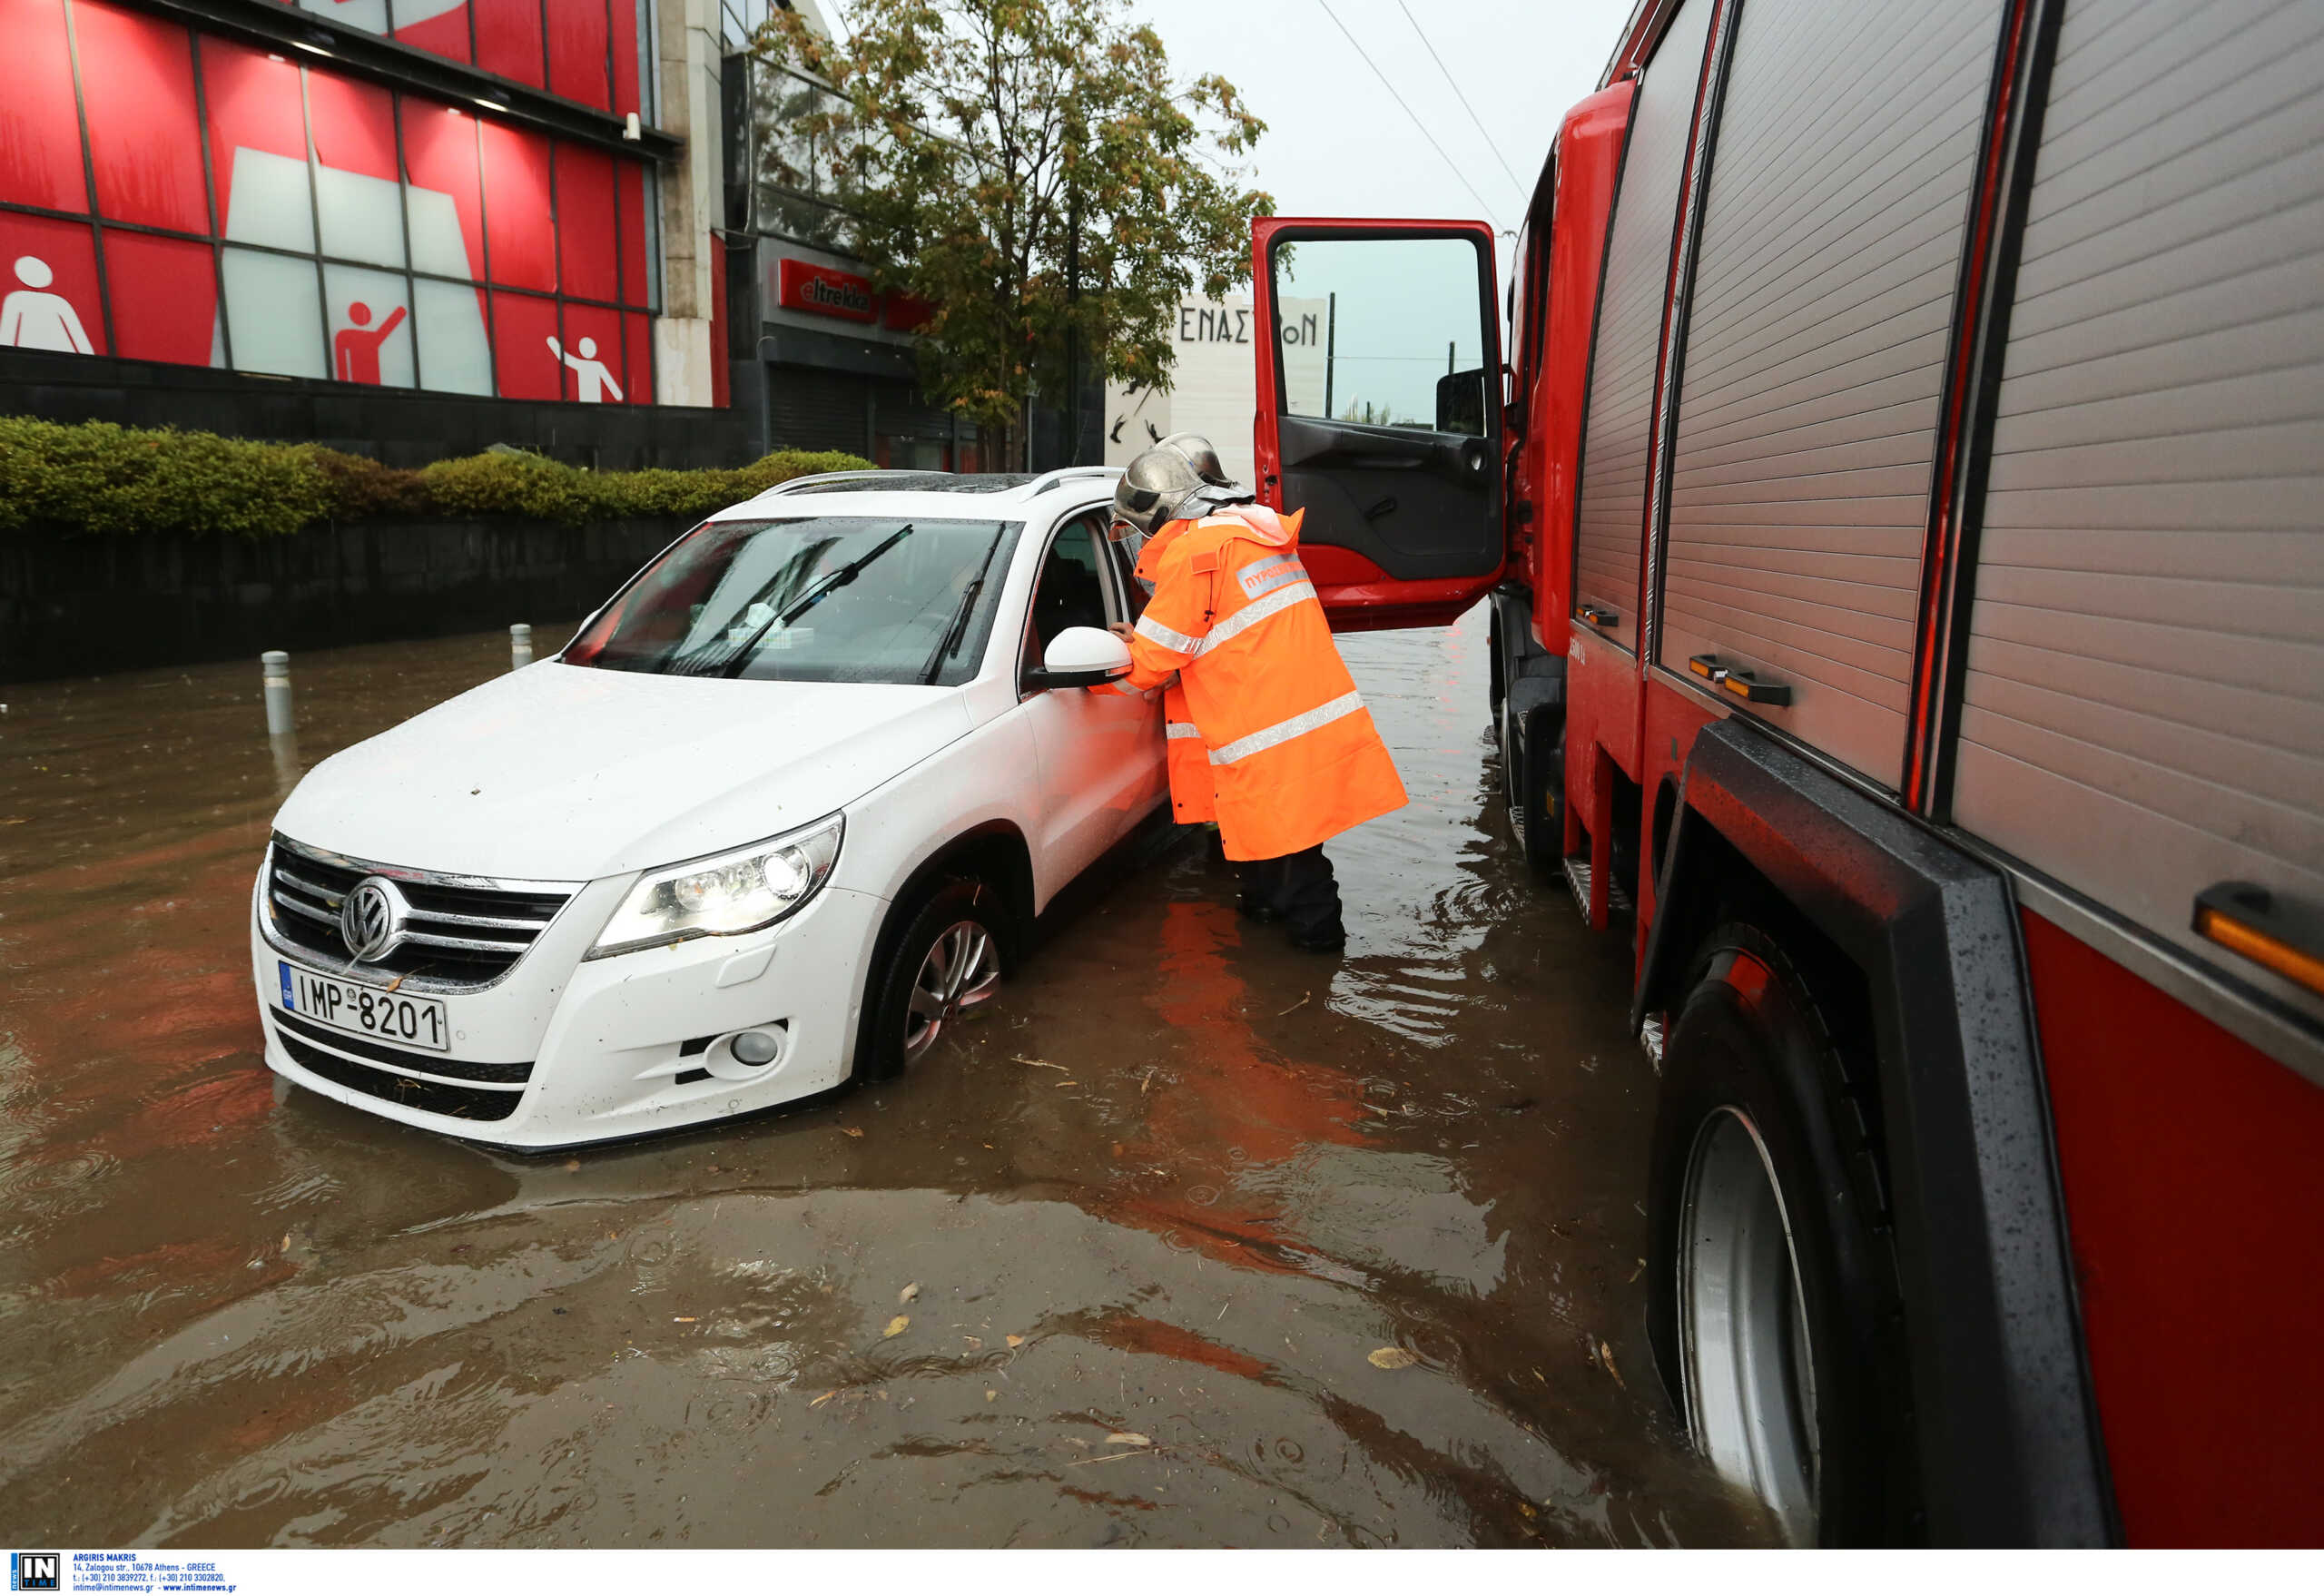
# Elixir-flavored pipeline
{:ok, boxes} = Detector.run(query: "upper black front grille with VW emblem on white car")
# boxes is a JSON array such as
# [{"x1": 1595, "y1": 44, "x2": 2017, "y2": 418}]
[{"x1": 267, "y1": 836, "x2": 576, "y2": 992}]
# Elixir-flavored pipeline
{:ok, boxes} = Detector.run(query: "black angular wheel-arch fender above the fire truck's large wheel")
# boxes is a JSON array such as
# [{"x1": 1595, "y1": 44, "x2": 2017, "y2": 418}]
[{"x1": 1631, "y1": 720, "x2": 2122, "y2": 1545}]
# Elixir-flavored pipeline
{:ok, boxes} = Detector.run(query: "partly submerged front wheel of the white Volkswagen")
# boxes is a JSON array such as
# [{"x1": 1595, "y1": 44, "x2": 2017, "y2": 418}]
[{"x1": 855, "y1": 878, "x2": 1006, "y2": 1080}]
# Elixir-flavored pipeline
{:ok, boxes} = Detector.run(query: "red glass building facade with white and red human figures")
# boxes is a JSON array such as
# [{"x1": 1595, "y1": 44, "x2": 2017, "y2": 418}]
[{"x1": 0, "y1": 0, "x2": 663, "y2": 404}]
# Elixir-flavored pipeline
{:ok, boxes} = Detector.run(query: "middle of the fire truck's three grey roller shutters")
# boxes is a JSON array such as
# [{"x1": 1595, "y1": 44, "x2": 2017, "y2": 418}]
[{"x1": 1657, "y1": 0, "x2": 2001, "y2": 787}]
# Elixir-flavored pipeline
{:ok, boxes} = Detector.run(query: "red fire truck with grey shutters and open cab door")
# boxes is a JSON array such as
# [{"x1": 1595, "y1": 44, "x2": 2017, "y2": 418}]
[{"x1": 1253, "y1": 0, "x2": 2324, "y2": 1545}]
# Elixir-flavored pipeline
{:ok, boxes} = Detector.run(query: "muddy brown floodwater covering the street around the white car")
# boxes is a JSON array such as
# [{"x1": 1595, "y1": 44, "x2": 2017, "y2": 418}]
[{"x1": 0, "y1": 611, "x2": 1771, "y2": 1547}]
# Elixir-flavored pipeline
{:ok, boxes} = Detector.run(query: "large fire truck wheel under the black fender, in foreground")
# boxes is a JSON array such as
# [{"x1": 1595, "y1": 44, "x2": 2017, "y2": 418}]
[{"x1": 1648, "y1": 924, "x2": 1913, "y2": 1545}]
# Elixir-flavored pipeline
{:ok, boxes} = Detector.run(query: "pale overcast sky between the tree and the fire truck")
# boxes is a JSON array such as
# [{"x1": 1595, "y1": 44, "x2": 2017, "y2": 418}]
[{"x1": 1132, "y1": 0, "x2": 1631, "y2": 249}]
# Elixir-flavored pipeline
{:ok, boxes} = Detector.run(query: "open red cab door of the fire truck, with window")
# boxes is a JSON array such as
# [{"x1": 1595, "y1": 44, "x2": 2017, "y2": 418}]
[{"x1": 1250, "y1": 216, "x2": 1503, "y2": 632}]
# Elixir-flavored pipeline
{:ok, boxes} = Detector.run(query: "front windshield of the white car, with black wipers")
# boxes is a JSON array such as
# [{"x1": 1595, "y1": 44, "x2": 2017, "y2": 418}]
[{"x1": 563, "y1": 516, "x2": 1022, "y2": 685}]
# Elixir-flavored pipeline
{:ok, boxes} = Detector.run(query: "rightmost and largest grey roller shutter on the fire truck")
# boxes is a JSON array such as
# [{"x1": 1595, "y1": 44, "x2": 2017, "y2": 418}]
[{"x1": 1952, "y1": 0, "x2": 2324, "y2": 1049}]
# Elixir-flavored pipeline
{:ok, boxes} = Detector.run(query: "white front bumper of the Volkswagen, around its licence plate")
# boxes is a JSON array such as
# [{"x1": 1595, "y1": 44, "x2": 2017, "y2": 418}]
[{"x1": 251, "y1": 878, "x2": 888, "y2": 1150}]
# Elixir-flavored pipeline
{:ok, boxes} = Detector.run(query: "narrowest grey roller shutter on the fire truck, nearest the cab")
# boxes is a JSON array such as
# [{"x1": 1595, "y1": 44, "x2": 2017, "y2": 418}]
[{"x1": 1573, "y1": 0, "x2": 1713, "y2": 648}]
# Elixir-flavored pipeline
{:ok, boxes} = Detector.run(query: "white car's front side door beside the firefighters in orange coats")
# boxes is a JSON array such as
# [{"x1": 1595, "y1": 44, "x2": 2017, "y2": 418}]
[{"x1": 1018, "y1": 508, "x2": 1167, "y2": 892}]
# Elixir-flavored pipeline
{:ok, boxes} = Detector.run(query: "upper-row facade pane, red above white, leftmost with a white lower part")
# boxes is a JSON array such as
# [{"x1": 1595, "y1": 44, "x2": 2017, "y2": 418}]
[{"x1": 202, "y1": 37, "x2": 320, "y2": 252}]
